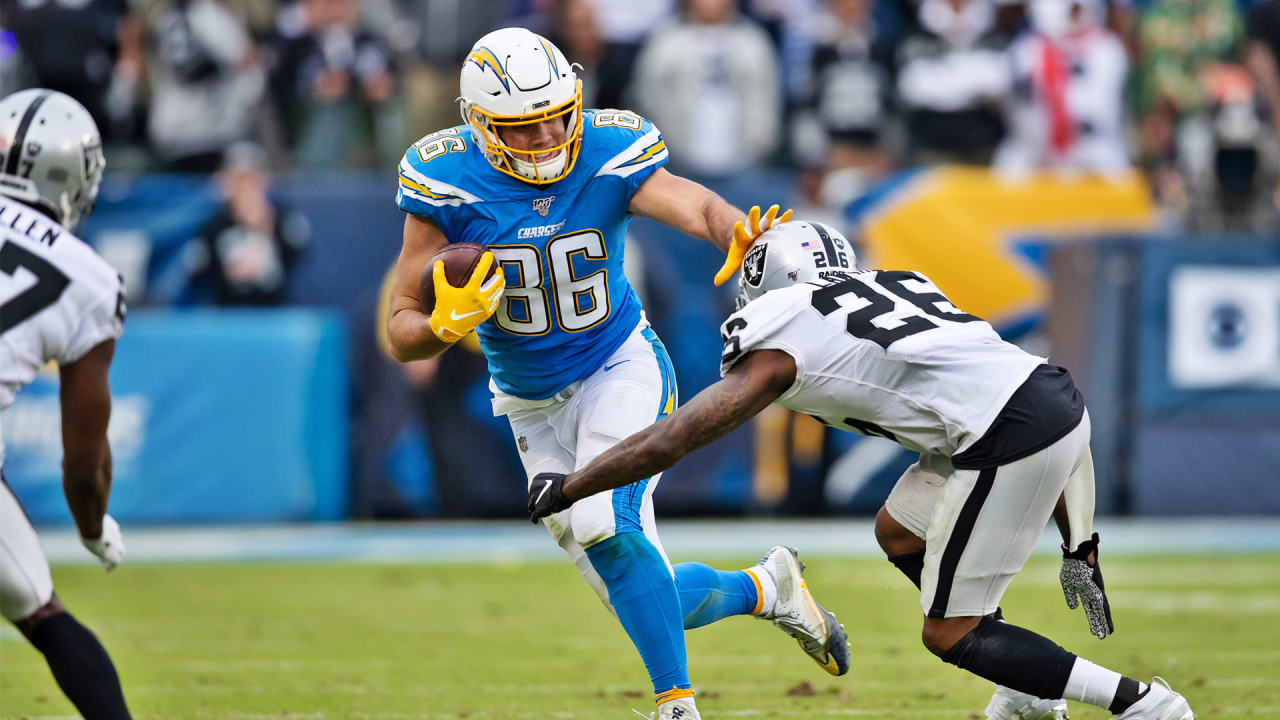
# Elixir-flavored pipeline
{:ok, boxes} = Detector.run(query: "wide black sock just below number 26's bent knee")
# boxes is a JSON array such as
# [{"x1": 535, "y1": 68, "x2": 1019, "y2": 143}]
[{"x1": 942, "y1": 609, "x2": 1075, "y2": 700}]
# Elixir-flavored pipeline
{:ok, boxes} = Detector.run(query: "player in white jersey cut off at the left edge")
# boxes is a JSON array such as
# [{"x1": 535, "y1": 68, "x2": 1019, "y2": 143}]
[{"x1": 0, "y1": 90, "x2": 129, "y2": 720}]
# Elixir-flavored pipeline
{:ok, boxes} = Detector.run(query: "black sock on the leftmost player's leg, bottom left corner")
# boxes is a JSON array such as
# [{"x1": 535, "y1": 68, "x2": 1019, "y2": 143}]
[{"x1": 31, "y1": 612, "x2": 131, "y2": 720}]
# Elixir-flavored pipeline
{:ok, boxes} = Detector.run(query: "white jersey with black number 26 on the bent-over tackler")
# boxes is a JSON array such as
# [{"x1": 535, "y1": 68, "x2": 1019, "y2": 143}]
[{"x1": 721, "y1": 270, "x2": 1046, "y2": 457}]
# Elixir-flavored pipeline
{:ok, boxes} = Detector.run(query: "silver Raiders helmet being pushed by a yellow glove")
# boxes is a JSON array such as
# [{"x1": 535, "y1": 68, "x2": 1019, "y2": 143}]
[{"x1": 736, "y1": 220, "x2": 858, "y2": 310}]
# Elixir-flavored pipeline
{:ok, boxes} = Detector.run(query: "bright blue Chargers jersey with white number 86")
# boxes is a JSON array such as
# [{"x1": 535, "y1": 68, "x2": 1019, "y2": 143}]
[{"x1": 396, "y1": 110, "x2": 667, "y2": 400}]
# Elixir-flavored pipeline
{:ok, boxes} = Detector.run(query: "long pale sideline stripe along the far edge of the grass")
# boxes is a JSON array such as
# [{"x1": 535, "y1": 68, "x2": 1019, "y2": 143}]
[{"x1": 27, "y1": 518, "x2": 1280, "y2": 565}]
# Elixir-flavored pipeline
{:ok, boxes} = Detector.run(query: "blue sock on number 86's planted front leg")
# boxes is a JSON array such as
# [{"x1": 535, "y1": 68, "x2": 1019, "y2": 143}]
[{"x1": 586, "y1": 533, "x2": 690, "y2": 694}]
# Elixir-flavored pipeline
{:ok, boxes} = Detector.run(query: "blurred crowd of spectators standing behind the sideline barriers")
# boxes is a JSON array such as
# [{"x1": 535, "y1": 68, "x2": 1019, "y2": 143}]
[{"x1": 0, "y1": 0, "x2": 1280, "y2": 226}]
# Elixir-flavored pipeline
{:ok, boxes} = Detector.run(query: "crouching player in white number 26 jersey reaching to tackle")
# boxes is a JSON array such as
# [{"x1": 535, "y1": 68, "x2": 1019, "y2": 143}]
[{"x1": 529, "y1": 222, "x2": 1193, "y2": 720}]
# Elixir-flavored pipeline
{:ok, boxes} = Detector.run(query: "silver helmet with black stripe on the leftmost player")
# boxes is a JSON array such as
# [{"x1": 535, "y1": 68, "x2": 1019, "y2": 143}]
[{"x1": 0, "y1": 88, "x2": 106, "y2": 232}]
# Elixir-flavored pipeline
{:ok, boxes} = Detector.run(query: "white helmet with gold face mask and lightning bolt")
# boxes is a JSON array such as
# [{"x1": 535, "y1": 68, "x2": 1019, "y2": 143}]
[{"x1": 458, "y1": 27, "x2": 582, "y2": 184}]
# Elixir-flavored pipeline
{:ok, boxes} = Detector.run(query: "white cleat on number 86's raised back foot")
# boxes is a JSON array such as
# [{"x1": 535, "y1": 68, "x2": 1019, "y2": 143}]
[{"x1": 753, "y1": 544, "x2": 849, "y2": 675}]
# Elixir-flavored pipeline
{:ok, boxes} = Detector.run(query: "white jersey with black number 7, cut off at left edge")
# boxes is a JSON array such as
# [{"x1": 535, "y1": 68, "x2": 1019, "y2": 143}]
[{"x1": 0, "y1": 196, "x2": 125, "y2": 462}]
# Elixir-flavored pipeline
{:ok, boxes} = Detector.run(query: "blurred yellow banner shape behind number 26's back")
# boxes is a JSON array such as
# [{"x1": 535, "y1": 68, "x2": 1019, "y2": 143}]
[{"x1": 854, "y1": 167, "x2": 1156, "y2": 328}]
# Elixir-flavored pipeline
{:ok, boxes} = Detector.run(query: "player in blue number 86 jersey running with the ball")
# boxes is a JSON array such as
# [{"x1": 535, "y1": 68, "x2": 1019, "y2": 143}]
[{"x1": 388, "y1": 28, "x2": 849, "y2": 720}]
